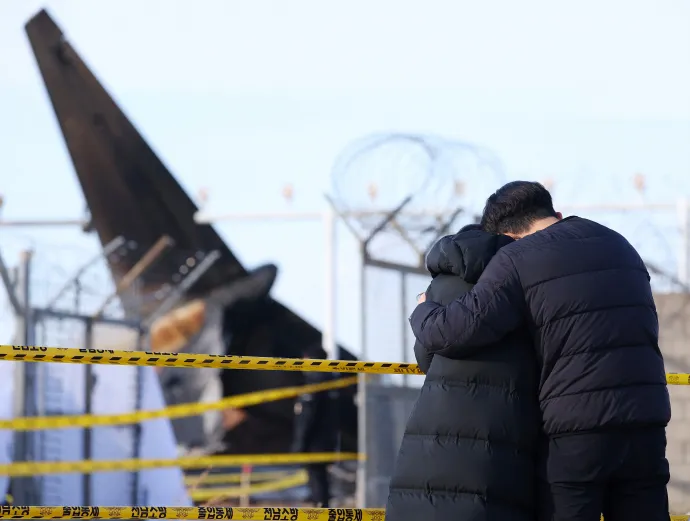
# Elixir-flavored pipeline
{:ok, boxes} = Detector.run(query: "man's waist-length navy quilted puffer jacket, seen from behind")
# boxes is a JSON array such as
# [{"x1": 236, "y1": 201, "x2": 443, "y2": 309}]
[{"x1": 410, "y1": 217, "x2": 671, "y2": 436}]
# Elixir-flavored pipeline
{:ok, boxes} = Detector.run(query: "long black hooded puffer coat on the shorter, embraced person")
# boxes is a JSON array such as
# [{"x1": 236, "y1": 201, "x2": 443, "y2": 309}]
[{"x1": 386, "y1": 229, "x2": 540, "y2": 521}]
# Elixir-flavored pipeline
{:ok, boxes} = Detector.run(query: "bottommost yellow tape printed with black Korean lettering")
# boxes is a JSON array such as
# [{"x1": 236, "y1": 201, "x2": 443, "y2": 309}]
[{"x1": 0, "y1": 507, "x2": 388, "y2": 521}]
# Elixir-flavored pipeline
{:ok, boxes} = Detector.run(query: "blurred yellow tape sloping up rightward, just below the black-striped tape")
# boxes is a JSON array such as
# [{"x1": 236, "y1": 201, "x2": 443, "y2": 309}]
[{"x1": 0, "y1": 376, "x2": 357, "y2": 431}]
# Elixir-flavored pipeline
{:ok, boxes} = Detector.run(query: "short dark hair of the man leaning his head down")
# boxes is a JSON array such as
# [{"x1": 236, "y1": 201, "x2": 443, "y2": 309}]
[{"x1": 482, "y1": 181, "x2": 556, "y2": 234}]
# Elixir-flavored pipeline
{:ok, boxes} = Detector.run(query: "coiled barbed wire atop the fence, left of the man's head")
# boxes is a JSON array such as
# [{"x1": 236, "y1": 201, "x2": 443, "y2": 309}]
[{"x1": 331, "y1": 133, "x2": 505, "y2": 257}]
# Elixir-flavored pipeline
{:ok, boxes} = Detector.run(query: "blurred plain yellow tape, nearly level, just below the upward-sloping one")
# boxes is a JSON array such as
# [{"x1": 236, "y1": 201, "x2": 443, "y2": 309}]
[{"x1": 0, "y1": 452, "x2": 364, "y2": 476}]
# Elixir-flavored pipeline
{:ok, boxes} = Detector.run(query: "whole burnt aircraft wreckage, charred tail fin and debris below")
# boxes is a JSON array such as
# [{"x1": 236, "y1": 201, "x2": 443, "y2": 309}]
[{"x1": 26, "y1": 10, "x2": 357, "y2": 453}]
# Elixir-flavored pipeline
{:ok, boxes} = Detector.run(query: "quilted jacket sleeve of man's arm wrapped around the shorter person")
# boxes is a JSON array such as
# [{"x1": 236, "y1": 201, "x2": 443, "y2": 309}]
[{"x1": 410, "y1": 250, "x2": 526, "y2": 359}]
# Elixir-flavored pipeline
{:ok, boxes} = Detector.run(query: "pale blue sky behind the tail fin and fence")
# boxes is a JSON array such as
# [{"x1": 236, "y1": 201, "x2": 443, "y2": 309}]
[{"x1": 0, "y1": 0, "x2": 690, "y2": 368}]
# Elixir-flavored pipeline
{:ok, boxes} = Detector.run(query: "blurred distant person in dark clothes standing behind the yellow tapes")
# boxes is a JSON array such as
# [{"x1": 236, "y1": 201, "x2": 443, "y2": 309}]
[{"x1": 292, "y1": 350, "x2": 338, "y2": 508}]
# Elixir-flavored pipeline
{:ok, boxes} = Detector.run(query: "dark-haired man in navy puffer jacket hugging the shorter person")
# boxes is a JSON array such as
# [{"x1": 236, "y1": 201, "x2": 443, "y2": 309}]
[{"x1": 410, "y1": 181, "x2": 671, "y2": 521}]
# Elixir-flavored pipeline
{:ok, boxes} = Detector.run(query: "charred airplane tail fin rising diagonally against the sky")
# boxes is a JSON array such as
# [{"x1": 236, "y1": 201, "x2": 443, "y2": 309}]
[{"x1": 26, "y1": 10, "x2": 246, "y2": 300}]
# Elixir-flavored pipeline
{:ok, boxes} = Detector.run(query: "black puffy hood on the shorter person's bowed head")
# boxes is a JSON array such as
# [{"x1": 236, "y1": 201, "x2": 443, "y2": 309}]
[{"x1": 426, "y1": 224, "x2": 513, "y2": 284}]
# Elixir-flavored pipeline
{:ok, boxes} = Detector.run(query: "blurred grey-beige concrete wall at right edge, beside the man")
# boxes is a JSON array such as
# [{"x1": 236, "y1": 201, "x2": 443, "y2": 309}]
[{"x1": 655, "y1": 294, "x2": 690, "y2": 513}]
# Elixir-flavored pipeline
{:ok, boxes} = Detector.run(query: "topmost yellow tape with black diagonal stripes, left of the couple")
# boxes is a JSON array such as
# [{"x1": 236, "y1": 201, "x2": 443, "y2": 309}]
[{"x1": 0, "y1": 345, "x2": 423, "y2": 374}]
